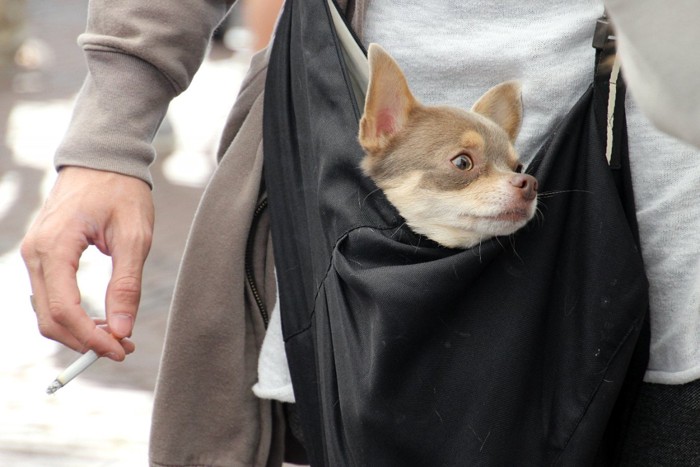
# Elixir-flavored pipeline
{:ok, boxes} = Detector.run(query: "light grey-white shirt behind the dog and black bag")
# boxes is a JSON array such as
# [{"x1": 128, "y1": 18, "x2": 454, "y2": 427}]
[{"x1": 361, "y1": 0, "x2": 700, "y2": 384}]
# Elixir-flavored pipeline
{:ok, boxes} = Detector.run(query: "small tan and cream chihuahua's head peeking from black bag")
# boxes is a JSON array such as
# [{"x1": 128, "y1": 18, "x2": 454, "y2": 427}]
[{"x1": 359, "y1": 44, "x2": 537, "y2": 248}]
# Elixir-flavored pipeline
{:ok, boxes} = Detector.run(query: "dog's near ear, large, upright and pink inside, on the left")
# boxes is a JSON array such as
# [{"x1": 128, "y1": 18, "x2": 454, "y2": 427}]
[{"x1": 359, "y1": 44, "x2": 416, "y2": 152}]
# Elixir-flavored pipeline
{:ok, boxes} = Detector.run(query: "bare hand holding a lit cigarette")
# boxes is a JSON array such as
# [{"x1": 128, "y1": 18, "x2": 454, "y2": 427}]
[{"x1": 21, "y1": 167, "x2": 154, "y2": 361}]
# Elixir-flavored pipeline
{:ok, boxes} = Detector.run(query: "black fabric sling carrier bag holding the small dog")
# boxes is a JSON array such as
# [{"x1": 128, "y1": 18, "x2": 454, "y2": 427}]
[{"x1": 264, "y1": 0, "x2": 648, "y2": 467}]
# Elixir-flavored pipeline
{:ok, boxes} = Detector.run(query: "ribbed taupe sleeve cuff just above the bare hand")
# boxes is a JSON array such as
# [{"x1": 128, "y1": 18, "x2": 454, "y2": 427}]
[{"x1": 54, "y1": 49, "x2": 177, "y2": 186}]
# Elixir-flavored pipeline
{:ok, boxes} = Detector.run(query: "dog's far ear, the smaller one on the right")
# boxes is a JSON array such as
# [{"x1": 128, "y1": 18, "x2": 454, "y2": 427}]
[{"x1": 472, "y1": 81, "x2": 523, "y2": 143}]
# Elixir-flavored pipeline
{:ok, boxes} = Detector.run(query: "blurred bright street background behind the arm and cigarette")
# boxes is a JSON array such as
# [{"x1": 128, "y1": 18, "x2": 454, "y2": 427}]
[{"x1": 0, "y1": 0, "x2": 279, "y2": 467}]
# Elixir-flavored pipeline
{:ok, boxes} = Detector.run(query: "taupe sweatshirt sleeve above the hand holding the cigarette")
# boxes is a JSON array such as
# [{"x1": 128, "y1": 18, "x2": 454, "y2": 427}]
[{"x1": 55, "y1": 0, "x2": 233, "y2": 184}]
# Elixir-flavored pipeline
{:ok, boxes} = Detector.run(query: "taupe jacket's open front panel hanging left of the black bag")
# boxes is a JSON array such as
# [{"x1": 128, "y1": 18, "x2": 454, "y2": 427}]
[{"x1": 150, "y1": 1, "x2": 364, "y2": 466}]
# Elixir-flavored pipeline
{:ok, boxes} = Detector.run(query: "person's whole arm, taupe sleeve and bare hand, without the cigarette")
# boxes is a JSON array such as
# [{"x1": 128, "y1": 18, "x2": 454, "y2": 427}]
[{"x1": 22, "y1": 0, "x2": 235, "y2": 360}]
